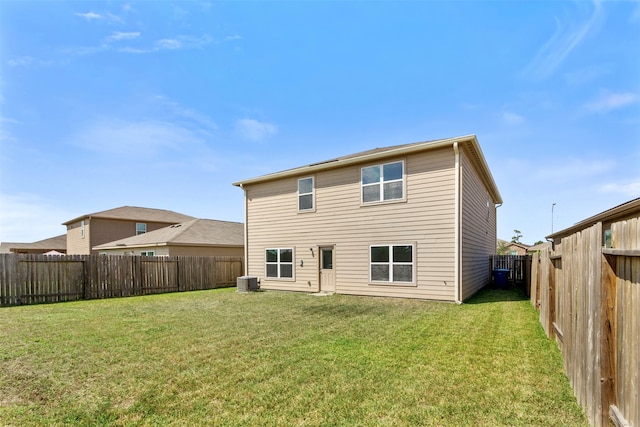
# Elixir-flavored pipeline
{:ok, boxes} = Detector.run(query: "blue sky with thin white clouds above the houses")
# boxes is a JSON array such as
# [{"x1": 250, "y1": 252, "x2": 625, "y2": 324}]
[{"x1": 0, "y1": 0, "x2": 640, "y2": 243}]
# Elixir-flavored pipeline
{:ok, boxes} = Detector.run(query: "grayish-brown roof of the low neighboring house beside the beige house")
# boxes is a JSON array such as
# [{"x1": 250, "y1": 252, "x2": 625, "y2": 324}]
[{"x1": 93, "y1": 219, "x2": 244, "y2": 250}]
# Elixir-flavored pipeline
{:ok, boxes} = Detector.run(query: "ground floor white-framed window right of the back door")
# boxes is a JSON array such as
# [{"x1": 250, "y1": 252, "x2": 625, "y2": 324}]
[{"x1": 369, "y1": 244, "x2": 415, "y2": 283}]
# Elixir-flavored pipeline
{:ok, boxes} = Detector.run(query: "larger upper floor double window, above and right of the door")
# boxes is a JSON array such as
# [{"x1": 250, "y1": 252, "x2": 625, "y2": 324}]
[{"x1": 362, "y1": 161, "x2": 404, "y2": 203}]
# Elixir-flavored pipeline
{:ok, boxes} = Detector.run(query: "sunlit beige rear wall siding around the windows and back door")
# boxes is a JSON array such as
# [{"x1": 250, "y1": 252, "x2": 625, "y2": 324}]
[{"x1": 245, "y1": 148, "x2": 455, "y2": 301}]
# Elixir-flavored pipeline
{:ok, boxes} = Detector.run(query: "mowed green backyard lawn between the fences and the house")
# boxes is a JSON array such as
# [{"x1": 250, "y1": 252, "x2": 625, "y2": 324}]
[{"x1": 0, "y1": 289, "x2": 588, "y2": 426}]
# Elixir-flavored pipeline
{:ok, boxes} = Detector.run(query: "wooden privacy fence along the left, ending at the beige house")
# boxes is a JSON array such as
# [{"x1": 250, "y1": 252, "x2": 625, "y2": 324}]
[{"x1": 0, "y1": 254, "x2": 244, "y2": 306}]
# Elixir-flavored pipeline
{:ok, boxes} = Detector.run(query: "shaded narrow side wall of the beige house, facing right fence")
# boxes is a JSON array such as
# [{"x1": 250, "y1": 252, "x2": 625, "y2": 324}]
[{"x1": 460, "y1": 145, "x2": 496, "y2": 301}]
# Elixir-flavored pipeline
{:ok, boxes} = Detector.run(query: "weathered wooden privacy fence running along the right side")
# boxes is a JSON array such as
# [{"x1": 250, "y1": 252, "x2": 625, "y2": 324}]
[{"x1": 531, "y1": 218, "x2": 640, "y2": 426}]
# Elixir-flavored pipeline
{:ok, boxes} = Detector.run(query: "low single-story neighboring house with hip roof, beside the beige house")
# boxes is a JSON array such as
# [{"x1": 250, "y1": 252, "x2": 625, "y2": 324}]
[{"x1": 93, "y1": 219, "x2": 244, "y2": 256}]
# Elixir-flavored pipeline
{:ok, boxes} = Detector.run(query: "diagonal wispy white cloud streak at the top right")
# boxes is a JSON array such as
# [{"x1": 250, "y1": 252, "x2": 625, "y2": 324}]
[{"x1": 523, "y1": 0, "x2": 603, "y2": 79}]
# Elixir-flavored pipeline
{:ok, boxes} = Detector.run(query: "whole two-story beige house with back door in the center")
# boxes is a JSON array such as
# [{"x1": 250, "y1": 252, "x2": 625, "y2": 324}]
[{"x1": 234, "y1": 135, "x2": 502, "y2": 302}]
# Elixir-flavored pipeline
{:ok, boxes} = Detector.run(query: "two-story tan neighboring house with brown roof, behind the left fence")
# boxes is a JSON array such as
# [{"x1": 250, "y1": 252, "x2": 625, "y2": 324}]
[{"x1": 63, "y1": 206, "x2": 195, "y2": 255}]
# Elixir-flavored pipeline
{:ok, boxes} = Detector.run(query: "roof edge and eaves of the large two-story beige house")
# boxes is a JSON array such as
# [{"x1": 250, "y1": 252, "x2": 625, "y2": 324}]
[{"x1": 233, "y1": 135, "x2": 502, "y2": 203}]
